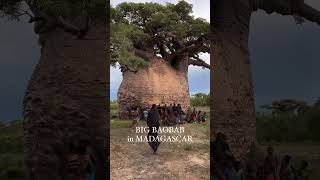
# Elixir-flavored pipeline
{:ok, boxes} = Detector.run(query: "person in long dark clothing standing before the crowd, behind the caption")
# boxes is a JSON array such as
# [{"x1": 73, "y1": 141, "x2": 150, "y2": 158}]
[{"x1": 147, "y1": 109, "x2": 160, "y2": 152}]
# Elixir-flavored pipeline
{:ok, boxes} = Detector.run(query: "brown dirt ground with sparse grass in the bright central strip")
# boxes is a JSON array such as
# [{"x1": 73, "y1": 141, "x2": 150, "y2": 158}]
[{"x1": 110, "y1": 120, "x2": 210, "y2": 180}]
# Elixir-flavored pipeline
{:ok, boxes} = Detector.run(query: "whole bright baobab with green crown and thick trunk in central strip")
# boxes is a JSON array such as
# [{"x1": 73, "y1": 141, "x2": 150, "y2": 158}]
[{"x1": 111, "y1": 1, "x2": 210, "y2": 118}]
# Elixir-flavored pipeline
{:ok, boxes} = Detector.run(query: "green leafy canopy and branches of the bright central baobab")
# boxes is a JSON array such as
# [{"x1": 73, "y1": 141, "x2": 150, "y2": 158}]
[{"x1": 110, "y1": 1, "x2": 209, "y2": 70}]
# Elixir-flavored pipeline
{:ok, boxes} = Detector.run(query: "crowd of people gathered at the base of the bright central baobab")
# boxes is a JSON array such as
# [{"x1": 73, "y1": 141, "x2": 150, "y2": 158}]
[{"x1": 129, "y1": 104, "x2": 207, "y2": 126}]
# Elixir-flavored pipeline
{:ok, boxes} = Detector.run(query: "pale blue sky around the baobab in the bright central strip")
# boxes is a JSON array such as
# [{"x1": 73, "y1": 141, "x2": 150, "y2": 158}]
[{"x1": 110, "y1": 0, "x2": 210, "y2": 100}]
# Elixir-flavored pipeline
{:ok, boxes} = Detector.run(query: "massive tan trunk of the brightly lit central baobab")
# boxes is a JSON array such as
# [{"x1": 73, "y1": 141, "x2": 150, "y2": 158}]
[{"x1": 118, "y1": 56, "x2": 190, "y2": 119}]
